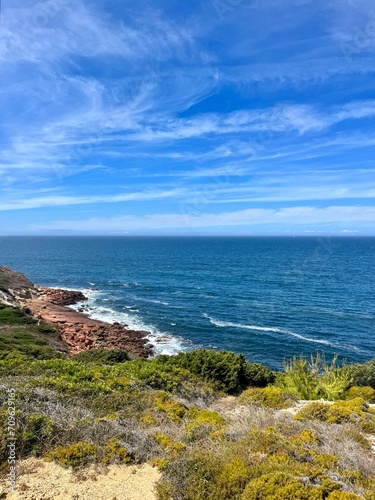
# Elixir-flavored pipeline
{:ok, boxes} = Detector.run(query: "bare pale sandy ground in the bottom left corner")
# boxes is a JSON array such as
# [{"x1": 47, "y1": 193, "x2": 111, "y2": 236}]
[{"x1": 0, "y1": 458, "x2": 161, "y2": 500}]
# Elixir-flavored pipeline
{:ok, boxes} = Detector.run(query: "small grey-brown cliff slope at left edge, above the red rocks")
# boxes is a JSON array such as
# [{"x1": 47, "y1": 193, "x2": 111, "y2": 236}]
[{"x1": 0, "y1": 266, "x2": 39, "y2": 307}]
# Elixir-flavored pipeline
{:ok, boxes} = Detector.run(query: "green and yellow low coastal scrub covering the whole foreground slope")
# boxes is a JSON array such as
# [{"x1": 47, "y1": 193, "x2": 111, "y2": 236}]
[{"x1": 0, "y1": 306, "x2": 375, "y2": 500}]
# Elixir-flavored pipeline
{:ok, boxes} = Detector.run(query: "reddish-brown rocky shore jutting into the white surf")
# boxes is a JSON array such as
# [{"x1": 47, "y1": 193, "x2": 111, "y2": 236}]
[{"x1": 0, "y1": 267, "x2": 153, "y2": 358}]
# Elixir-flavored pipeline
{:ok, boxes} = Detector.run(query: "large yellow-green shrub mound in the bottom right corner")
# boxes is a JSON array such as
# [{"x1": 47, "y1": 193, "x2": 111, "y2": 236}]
[{"x1": 157, "y1": 423, "x2": 373, "y2": 500}]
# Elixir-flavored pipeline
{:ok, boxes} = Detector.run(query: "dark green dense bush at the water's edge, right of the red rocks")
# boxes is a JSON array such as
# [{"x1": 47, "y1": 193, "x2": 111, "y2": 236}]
[{"x1": 155, "y1": 349, "x2": 275, "y2": 394}]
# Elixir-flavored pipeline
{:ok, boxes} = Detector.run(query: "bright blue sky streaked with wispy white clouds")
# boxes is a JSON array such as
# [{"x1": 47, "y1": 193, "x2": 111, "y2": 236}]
[{"x1": 0, "y1": 0, "x2": 375, "y2": 236}]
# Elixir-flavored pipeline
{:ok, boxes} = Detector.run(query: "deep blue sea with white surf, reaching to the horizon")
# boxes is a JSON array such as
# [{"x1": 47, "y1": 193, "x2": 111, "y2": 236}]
[{"x1": 0, "y1": 237, "x2": 375, "y2": 368}]
